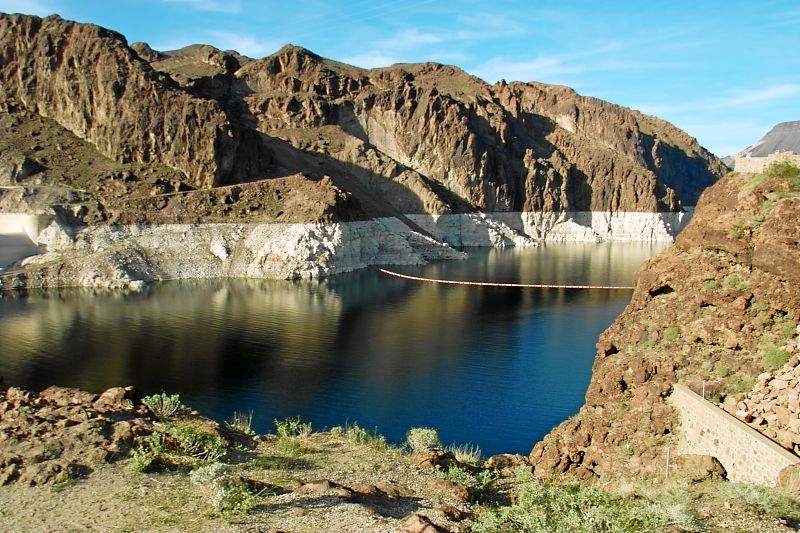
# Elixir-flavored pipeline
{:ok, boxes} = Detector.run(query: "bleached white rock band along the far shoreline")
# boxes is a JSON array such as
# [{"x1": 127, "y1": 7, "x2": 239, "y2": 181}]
[{"x1": 0, "y1": 212, "x2": 688, "y2": 288}]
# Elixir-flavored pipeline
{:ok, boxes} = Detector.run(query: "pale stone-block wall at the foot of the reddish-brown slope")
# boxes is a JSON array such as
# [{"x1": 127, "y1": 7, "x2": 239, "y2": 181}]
[{"x1": 670, "y1": 385, "x2": 800, "y2": 487}]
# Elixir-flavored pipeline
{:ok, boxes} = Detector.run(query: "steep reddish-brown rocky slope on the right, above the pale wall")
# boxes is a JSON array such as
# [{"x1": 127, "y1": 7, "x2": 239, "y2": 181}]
[{"x1": 531, "y1": 163, "x2": 800, "y2": 477}]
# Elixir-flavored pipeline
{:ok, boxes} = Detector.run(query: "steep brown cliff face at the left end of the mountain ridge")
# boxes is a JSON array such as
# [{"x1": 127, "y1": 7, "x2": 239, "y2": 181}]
[{"x1": 0, "y1": 14, "x2": 236, "y2": 187}]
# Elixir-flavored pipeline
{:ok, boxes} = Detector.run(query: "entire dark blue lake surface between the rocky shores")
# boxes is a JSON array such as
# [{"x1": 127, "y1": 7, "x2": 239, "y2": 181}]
[{"x1": 0, "y1": 243, "x2": 662, "y2": 454}]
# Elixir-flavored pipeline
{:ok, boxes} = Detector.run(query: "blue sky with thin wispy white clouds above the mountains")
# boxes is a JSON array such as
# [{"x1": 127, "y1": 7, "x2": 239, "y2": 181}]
[{"x1": 0, "y1": 0, "x2": 800, "y2": 156}]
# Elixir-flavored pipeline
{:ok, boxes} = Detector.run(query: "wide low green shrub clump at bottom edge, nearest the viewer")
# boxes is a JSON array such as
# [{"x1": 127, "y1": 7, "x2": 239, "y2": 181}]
[{"x1": 472, "y1": 481, "x2": 672, "y2": 533}]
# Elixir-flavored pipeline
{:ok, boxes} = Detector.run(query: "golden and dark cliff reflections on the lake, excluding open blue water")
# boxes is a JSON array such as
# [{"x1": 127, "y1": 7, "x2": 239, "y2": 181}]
[{"x1": 0, "y1": 244, "x2": 664, "y2": 408}]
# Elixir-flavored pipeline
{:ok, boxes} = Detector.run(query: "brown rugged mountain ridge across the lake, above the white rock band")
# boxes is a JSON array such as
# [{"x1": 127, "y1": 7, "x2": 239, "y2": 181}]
[{"x1": 0, "y1": 14, "x2": 724, "y2": 223}]
